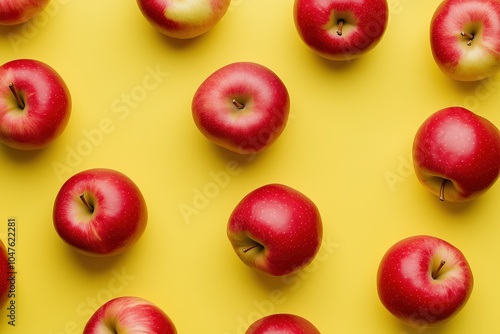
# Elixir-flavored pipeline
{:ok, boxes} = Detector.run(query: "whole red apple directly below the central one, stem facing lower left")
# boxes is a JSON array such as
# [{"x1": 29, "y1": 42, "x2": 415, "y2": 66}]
[{"x1": 227, "y1": 184, "x2": 323, "y2": 276}]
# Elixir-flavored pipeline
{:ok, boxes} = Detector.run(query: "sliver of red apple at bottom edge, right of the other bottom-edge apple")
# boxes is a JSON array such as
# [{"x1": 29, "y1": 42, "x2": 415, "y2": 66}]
[{"x1": 245, "y1": 313, "x2": 320, "y2": 334}]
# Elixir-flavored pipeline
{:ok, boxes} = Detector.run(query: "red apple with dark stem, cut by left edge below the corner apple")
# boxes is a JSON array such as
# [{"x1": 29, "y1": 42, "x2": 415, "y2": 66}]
[{"x1": 0, "y1": 59, "x2": 71, "y2": 150}]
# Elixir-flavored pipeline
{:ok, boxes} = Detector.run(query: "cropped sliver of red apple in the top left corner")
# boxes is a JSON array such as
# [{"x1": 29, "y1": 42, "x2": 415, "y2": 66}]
[{"x1": 0, "y1": 0, "x2": 50, "y2": 25}]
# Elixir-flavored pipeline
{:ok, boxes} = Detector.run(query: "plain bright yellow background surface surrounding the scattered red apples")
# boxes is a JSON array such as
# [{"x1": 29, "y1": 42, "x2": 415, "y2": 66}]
[{"x1": 0, "y1": 0, "x2": 500, "y2": 334}]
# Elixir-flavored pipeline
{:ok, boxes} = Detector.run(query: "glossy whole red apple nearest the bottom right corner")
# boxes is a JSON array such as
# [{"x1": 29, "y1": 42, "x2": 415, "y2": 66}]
[{"x1": 377, "y1": 235, "x2": 474, "y2": 327}]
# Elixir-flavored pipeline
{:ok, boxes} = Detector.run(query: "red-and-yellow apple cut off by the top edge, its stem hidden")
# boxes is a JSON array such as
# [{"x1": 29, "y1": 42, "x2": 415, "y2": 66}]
[{"x1": 137, "y1": 0, "x2": 231, "y2": 39}]
